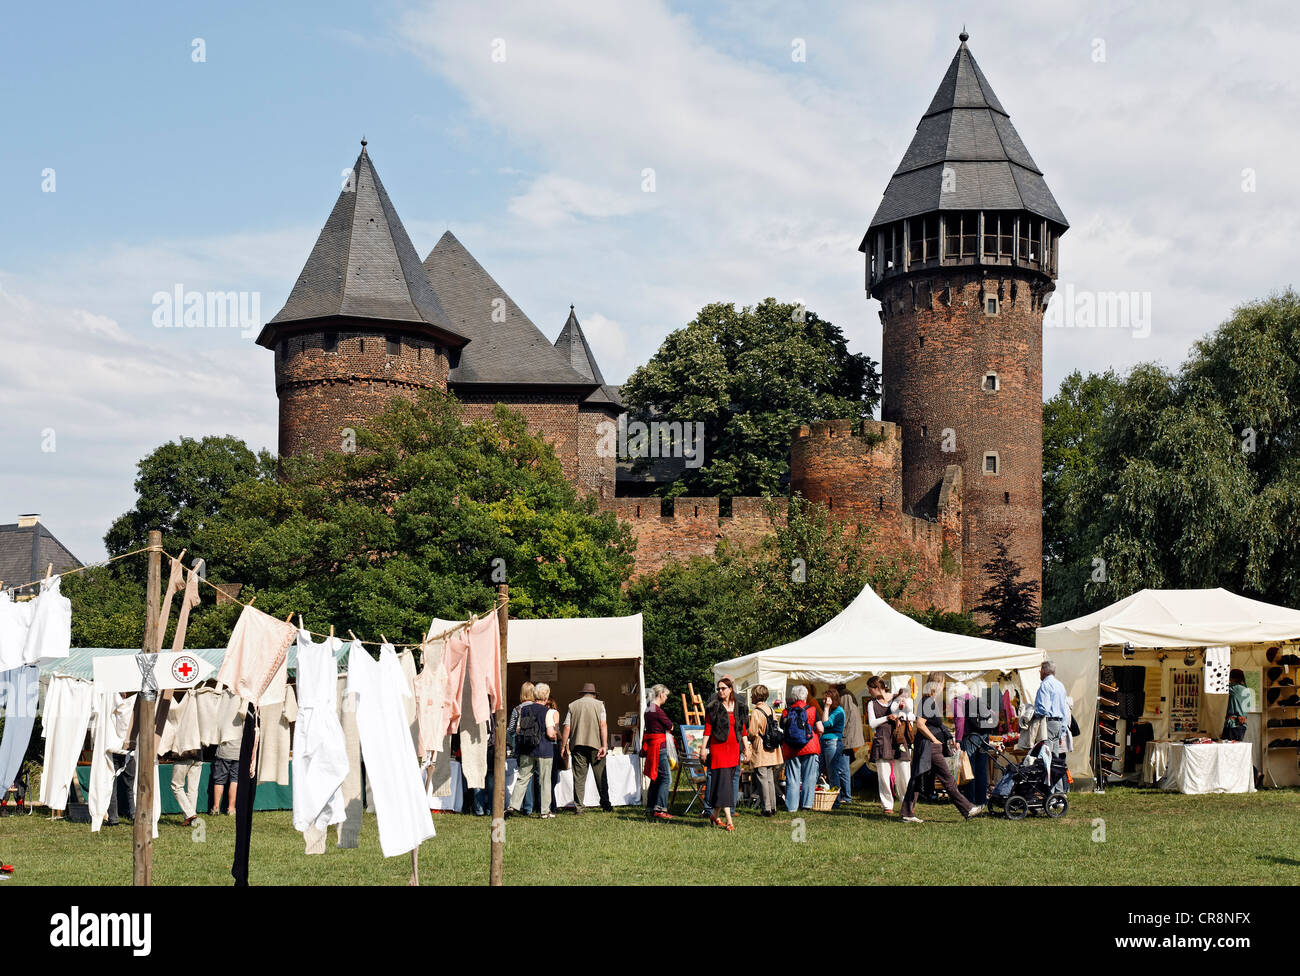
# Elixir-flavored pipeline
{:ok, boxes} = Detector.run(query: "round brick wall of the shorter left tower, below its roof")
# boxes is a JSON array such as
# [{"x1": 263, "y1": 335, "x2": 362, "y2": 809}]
[{"x1": 276, "y1": 329, "x2": 447, "y2": 456}]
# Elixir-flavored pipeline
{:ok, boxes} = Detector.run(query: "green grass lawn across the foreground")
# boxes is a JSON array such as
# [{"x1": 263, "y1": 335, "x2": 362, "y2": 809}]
[{"x1": 0, "y1": 788, "x2": 1300, "y2": 885}]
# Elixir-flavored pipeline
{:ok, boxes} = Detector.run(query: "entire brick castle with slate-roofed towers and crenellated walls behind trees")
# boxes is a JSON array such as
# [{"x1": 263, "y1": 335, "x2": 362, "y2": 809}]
[{"x1": 257, "y1": 31, "x2": 1069, "y2": 611}]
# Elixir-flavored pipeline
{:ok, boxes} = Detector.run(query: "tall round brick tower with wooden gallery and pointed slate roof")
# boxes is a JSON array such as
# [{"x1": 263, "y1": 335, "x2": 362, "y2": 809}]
[{"x1": 859, "y1": 31, "x2": 1069, "y2": 610}]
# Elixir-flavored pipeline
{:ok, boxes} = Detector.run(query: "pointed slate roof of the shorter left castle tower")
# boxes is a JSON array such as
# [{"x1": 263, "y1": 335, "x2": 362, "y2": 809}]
[{"x1": 257, "y1": 139, "x2": 465, "y2": 347}]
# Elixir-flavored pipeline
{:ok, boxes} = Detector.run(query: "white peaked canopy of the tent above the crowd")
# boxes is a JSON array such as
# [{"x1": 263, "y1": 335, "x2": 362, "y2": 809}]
[{"x1": 714, "y1": 585, "x2": 1043, "y2": 695}]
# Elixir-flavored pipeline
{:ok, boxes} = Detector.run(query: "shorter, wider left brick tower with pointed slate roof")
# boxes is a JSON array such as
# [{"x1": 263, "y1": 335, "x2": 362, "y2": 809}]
[{"x1": 257, "y1": 139, "x2": 468, "y2": 456}]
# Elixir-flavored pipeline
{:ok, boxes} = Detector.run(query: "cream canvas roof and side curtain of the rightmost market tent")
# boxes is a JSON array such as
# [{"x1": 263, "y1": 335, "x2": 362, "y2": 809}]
[{"x1": 1036, "y1": 589, "x2": 1300, "y2": 778}]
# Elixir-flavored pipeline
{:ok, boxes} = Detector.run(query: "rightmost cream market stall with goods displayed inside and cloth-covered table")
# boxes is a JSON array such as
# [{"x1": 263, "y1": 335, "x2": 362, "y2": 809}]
[{"x1": 1036, "y1": 589, "x2": 1300, "y2": 788}]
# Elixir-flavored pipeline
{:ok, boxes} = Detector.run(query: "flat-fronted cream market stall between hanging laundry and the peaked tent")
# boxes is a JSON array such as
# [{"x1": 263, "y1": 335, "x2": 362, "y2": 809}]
[{"x1": 429, "y1": 613, "x2": 645, "y2": 810}]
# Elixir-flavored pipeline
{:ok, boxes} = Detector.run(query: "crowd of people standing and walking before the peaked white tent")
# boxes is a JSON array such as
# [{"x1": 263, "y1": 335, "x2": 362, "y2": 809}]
[{"x1": 629, "y1": 661, "x2": 1070, "y2": 830}]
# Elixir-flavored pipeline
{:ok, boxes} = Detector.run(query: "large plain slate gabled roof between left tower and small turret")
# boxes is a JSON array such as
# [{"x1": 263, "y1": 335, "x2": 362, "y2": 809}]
[{"x1": 424, "y1": 230, "x2": 597, "y2": 391}]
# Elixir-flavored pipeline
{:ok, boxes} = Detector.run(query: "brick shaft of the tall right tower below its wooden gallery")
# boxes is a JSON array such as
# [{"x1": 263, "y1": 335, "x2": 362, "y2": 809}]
[{"x1": 878, "y1": 269, "x2": 1052, "y2": 608}]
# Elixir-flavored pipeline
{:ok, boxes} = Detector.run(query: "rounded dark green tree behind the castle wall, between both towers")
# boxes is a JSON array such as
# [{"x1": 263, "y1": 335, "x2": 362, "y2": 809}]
[{"x1": 621, "y1": 298, "x2": 880, "y2": 495}]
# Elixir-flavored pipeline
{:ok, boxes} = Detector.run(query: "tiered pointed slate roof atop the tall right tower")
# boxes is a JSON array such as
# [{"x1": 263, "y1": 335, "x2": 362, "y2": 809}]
[{"x1": 871, "y1": 32, "x2": 1069, "y2": 235}]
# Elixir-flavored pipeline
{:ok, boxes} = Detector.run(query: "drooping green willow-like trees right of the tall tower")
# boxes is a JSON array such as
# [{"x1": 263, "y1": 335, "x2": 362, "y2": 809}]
[{"x1": 1044, "y1": 290, "x2": 1300, "y2": 620}]
